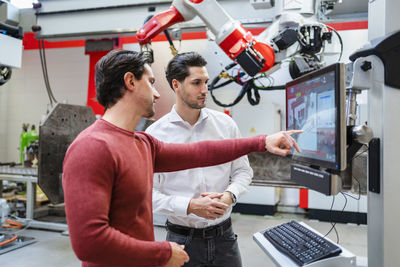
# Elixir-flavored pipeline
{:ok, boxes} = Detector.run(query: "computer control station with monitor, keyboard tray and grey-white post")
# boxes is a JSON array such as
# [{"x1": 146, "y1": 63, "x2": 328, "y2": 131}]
[{"x1": 254, "y1": 24, "x2": 400, "y2": 267}]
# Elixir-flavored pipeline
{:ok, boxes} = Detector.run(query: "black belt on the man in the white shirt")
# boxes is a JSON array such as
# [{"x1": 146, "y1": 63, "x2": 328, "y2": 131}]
[{"x1": 167, "y1": 218, "x2": 232, "y2": 239}]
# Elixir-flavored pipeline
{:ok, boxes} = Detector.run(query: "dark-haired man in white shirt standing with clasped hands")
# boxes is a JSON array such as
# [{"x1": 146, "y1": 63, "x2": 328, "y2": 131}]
[{"x1": 146, "y1": 52, "x2": 253, "y2": 267}]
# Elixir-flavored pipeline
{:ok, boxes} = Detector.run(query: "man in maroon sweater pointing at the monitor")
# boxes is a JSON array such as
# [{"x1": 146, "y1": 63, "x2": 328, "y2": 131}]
[{"x1": 63, "y1": 50, "x2": 300, "y2": 267}]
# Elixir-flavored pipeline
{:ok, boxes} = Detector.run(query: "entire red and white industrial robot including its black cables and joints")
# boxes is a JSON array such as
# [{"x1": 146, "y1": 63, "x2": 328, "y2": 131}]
[{"x1": 136, "y1": 0, "x2": 343, "y2": 107}]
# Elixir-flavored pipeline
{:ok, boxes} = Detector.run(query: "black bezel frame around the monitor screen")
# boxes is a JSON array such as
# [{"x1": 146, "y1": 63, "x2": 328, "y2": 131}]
[{"x1": 285, "y1": 63, "x2": 347, "y2": 171}]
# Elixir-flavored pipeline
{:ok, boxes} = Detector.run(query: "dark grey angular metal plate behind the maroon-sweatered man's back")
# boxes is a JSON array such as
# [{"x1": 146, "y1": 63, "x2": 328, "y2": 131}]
[{"x1": 38, "y1": 103, "x2": 96, "y2": 204}]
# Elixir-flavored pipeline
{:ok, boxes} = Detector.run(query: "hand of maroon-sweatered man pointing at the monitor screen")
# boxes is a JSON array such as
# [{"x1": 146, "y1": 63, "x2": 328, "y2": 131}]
[{"x1": 265, "y1": 130, "x2": 303, "y2": 156}]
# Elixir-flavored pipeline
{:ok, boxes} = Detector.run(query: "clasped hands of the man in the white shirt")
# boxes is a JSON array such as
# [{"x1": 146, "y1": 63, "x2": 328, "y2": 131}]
[{"x1": 187, "y1": 193, "x2": 229, "y2": 220}]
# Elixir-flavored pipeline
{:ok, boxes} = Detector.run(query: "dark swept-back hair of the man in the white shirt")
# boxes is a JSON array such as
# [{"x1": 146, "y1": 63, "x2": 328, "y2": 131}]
[{"x1": 165, "y1": 52, "x2": 207, "y2": 90}]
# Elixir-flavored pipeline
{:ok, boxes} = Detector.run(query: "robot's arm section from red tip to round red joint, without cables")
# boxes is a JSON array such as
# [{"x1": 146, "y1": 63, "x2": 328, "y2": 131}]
[{"x1": 136, "y1": 0, "x2": 275, "y2": 76}]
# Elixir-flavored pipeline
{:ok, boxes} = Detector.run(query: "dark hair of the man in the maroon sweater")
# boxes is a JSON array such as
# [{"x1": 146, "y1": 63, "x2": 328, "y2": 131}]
[{"x1": 95, "y1": 50, "x2": 149, "y2": 109}]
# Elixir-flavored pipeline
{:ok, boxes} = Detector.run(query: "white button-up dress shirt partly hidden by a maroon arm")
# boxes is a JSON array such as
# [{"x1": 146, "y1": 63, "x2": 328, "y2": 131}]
[{"x1": 146, "y1": 106, "x2": 253, "y2": 228}]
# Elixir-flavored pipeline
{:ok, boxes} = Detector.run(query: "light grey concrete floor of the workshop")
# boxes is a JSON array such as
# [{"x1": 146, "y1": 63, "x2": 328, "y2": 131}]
[{"x1": 0, "y1": 214, "x2": 367, "y2": 267}]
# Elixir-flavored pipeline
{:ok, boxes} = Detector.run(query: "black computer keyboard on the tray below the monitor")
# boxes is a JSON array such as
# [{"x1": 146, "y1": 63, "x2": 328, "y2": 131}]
[{"x1": 264, "y1": 221, "x2": 342, "y2": 266}]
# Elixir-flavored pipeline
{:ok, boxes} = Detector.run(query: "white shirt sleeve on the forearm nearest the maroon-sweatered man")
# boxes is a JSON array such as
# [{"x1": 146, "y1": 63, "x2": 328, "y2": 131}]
[{"x1": 153, "y1": 173, "x2": 191, "y2": 216}]
